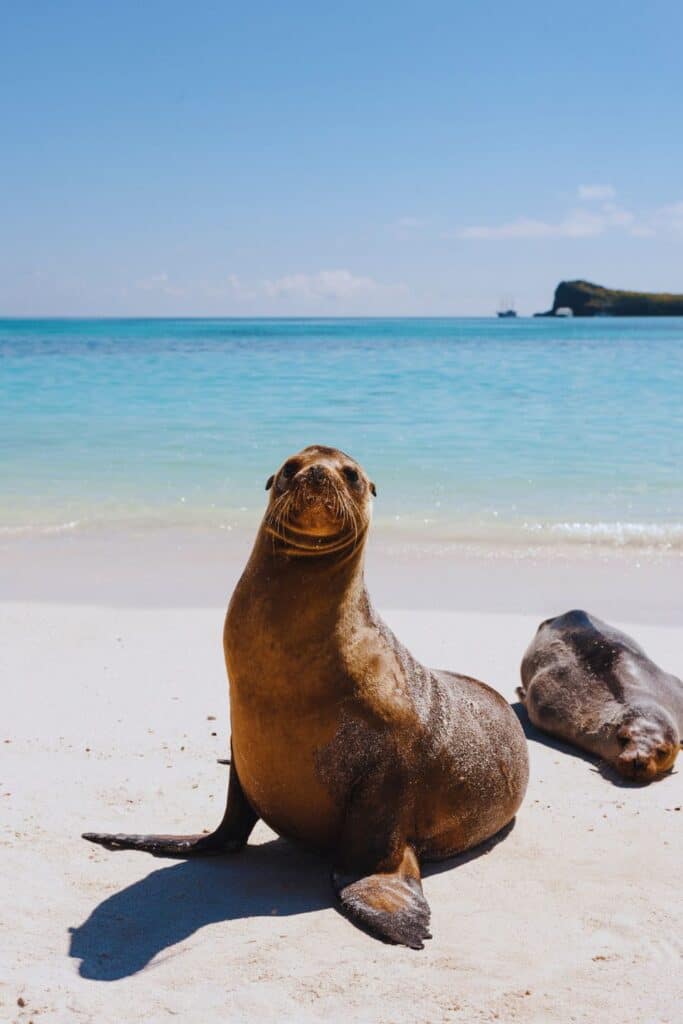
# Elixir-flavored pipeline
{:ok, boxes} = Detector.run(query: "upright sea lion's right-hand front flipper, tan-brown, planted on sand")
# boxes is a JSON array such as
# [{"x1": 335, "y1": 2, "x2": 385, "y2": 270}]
[{"x1": 332, "y1": 846, "x2": 431, "y2": 949}]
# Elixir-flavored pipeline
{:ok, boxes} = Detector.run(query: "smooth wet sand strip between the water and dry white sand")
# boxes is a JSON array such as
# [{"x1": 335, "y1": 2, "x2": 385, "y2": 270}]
[{"x1": 0, "y1": 528, "x2": 683, "y2": 626}]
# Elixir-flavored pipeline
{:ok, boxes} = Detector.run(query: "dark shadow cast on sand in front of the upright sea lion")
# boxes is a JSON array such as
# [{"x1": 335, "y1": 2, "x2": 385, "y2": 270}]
[{"x1": 69, "y1": 839, "x2": 332, "y2": 981}]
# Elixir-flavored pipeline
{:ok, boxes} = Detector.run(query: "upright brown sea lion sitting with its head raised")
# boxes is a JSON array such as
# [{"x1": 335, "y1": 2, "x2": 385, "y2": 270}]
[{"x1": 84, "y1": 445, "x2": 528, "y2": 949}]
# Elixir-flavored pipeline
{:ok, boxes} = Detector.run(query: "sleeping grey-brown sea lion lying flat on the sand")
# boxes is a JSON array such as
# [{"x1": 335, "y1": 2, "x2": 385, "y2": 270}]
[{"x1": 517, "y1": 610, "x2": 683, "y2": 782}]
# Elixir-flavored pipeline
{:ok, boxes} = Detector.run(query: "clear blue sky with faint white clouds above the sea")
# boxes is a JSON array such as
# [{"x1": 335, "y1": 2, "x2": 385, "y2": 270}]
[{"x1": 0, "y1": 0, "x2": 683, "y2": 315}]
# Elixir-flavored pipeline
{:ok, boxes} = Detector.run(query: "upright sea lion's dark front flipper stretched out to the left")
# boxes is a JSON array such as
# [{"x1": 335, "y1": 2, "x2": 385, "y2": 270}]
[{"x1": 83, "y1": 763, "x2": 258, "y2": 857}]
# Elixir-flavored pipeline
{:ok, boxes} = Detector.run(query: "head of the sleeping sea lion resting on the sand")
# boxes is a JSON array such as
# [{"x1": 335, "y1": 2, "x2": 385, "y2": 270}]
[{"x1": 614, "y1": 708, "x2": 680, "y2": 782}]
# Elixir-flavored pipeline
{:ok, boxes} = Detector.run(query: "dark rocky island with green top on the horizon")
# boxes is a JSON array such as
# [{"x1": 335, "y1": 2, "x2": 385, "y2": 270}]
[{"x1": 536, "y1": 281, "x2": 683, "y2": 316}]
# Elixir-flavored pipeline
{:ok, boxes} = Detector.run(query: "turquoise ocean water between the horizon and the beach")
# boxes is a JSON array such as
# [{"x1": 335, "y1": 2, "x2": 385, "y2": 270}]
[{"x1": 0, "y1": 318, "x2": 683, "y2": 549}]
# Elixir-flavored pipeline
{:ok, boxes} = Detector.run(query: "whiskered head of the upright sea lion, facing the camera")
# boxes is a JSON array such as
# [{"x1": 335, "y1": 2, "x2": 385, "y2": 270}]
[{"x1": 264, "y1": 444, "x2": 377, "y2": 554}]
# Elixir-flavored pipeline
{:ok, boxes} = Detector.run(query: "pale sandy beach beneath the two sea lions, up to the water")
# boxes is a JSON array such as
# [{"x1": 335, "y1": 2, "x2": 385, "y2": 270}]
[{"x1": 0, "y1": 544, "x2": 683, "y2": 1024}]
